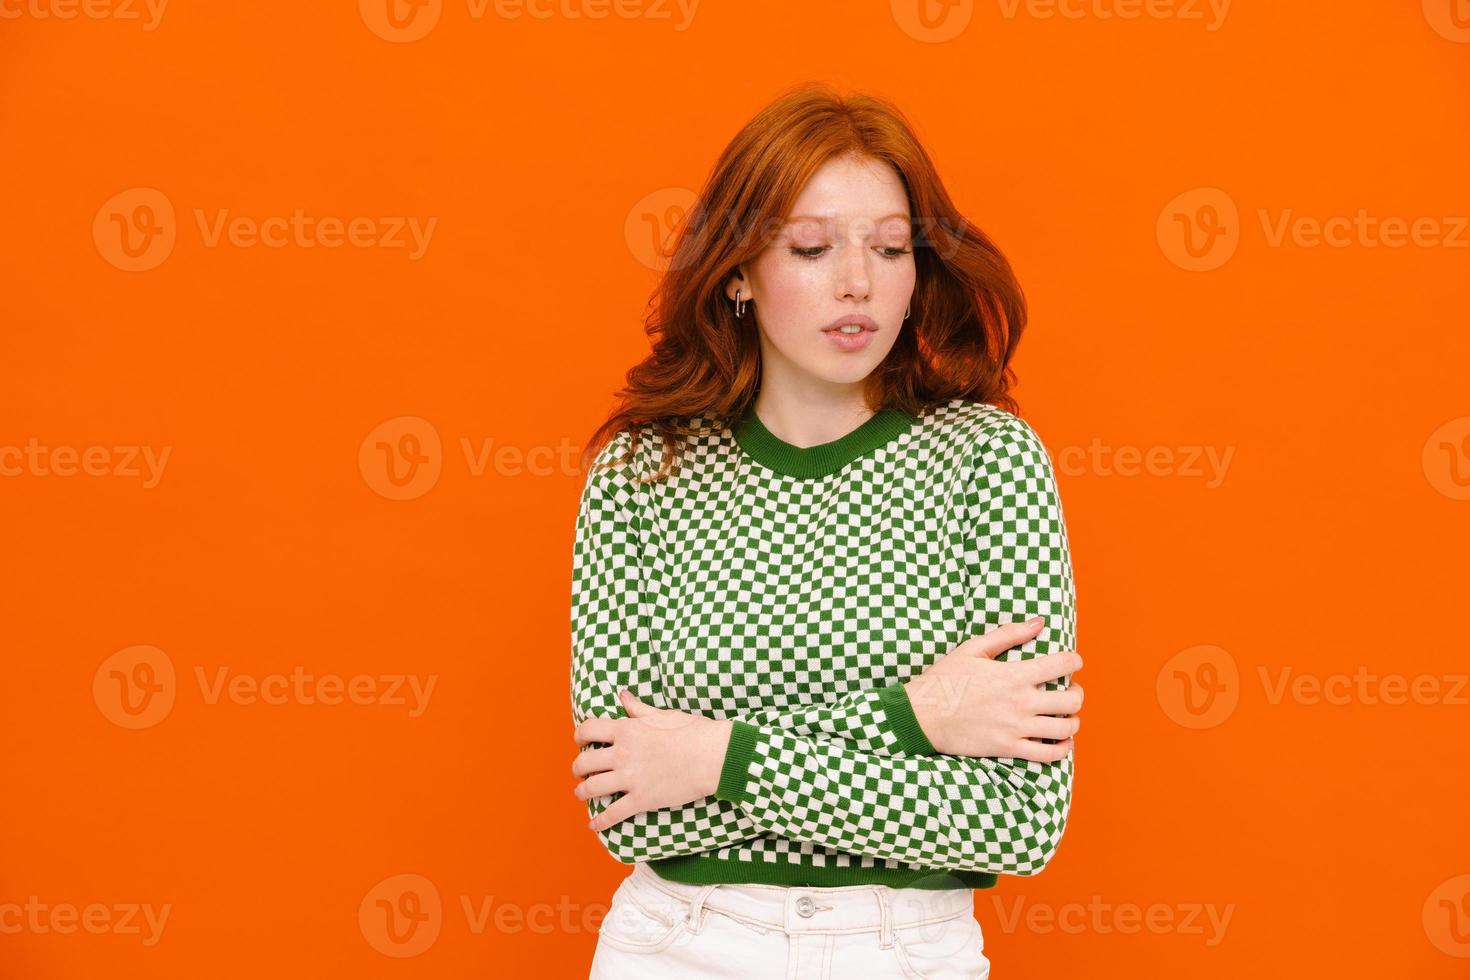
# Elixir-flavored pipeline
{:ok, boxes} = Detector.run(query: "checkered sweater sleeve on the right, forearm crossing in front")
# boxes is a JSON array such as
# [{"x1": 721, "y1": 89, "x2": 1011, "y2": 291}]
[{"x1": 716, "y1": 416, "x2": 1076, "y2": 876}]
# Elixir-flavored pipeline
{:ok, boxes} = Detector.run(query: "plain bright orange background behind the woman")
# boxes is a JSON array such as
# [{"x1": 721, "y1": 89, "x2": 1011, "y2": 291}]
[{"x1": 0, "y1": 0, "x2": 1470, "y2": 980}]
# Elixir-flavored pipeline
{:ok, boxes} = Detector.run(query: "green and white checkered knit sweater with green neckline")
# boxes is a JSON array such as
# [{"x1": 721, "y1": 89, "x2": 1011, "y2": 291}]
[{"x1": 570, "y1": 398, "x2": 1076, "y2": 889}]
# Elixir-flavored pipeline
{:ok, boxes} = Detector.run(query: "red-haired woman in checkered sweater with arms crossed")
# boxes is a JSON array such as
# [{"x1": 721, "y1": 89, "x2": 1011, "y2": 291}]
[{"x1": 570, "y1": 87, "x2": 1082, "y2": 980}]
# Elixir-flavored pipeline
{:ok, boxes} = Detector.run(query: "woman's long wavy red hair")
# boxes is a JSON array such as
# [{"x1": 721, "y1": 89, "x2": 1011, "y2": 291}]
[{"x1": 582, "y1": 84, "x2": 1026, "y2": 479}]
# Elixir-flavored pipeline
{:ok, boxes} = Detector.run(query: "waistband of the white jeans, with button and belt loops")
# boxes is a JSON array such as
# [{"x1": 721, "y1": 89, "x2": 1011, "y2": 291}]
[{"x1": 628, "y1": 862, "x2": 975, "y2": 948}]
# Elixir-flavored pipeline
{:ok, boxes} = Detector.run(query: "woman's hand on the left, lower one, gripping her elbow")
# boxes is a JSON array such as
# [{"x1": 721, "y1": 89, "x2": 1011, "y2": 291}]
[{"x1": 572, "y1": 691, "x2": 734, "y2": 830}]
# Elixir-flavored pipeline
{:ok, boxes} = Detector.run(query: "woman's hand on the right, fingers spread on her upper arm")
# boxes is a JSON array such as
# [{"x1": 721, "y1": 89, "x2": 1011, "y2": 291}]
[{"x1": 904, "y1": 617, "x2": 1082, "y2": 763}]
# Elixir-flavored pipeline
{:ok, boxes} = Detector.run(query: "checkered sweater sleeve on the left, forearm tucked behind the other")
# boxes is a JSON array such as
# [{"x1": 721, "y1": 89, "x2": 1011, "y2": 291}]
[{"x1": 570, "y1": 430, "x2": 935, "y2": 864}]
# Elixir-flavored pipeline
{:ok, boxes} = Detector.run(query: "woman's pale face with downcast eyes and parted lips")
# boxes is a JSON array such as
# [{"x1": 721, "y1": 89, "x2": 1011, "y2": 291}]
[{"x1": 725, "y1": 157, "x2": 914, "y2": 386}]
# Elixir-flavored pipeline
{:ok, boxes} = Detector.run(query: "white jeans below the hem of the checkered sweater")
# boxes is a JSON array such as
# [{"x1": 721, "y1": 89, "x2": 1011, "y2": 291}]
[{"x1": 588, "y1": 864, "x2": 991, "y2": 980}]
